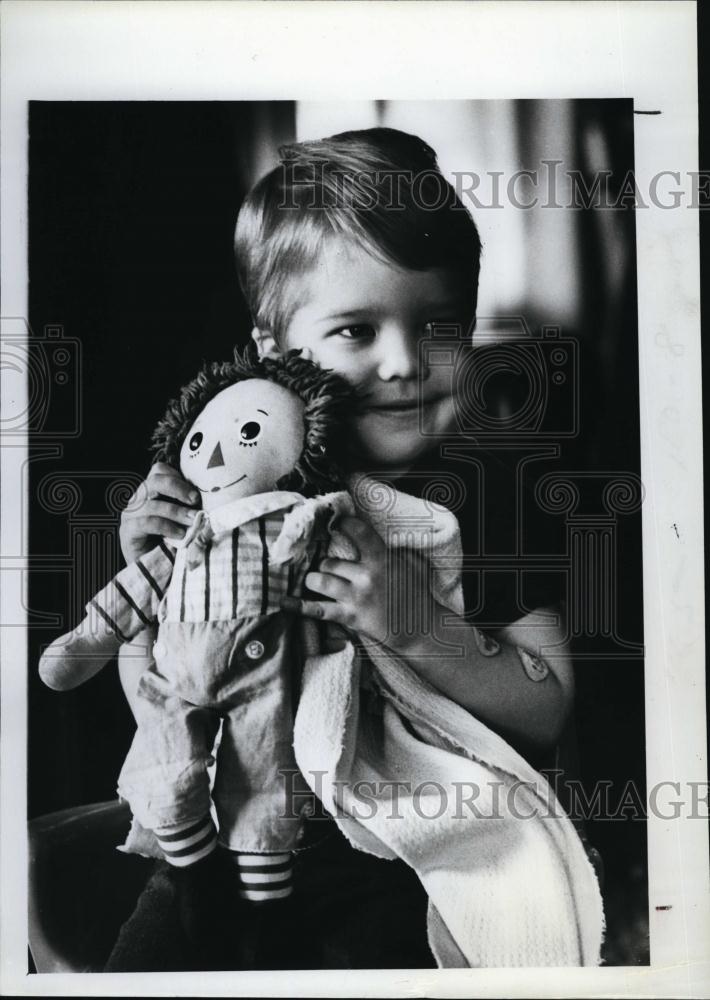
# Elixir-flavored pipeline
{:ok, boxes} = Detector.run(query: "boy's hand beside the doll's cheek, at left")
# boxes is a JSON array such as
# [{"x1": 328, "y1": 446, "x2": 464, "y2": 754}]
[{"x1": 120, "y1": 462, "x2": 200, "y2": 562}]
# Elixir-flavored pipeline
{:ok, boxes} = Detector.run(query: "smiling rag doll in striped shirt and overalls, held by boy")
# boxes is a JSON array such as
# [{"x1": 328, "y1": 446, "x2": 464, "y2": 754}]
[{"x1": 40, "y1": 349, "x2": 352, "y2": 936}]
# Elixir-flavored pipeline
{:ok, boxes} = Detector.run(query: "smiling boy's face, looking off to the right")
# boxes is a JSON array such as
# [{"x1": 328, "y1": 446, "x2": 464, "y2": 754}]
[{"x1": 281, "y1": 237, "x2": 473, "y2": 473}]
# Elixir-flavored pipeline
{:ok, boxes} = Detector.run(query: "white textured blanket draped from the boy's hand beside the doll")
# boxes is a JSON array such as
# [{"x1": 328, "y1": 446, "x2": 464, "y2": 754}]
[{"x1": 294, "y1": 479, "x2": 604, "y2": 968}]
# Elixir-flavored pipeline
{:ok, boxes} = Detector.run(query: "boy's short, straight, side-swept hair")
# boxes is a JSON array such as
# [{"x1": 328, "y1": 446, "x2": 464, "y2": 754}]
[{"x1": 235, "y1": 128, "x2": 481, "y2": 343}]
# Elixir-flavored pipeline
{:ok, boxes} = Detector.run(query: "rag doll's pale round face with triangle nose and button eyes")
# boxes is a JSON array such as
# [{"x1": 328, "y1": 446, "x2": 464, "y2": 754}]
[{"x1": 180, "y1": 378, "x2": 304, "y2": 511}]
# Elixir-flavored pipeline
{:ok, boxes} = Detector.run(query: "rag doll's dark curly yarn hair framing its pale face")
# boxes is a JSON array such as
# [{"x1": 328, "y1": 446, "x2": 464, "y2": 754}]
[{"x1": 151, "y1": 344, "x2": 355, "y2": 496}]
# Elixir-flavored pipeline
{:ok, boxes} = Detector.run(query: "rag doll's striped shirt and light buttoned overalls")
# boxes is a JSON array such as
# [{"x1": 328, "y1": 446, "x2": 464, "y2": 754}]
[{"x1": 92, "y1": 493, "x2": 344, "y2": 853}]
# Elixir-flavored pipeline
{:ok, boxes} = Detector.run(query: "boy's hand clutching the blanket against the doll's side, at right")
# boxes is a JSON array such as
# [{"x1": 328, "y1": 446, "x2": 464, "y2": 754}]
[{"x1": 282, "y1": 517, "x2": 432, "y2": 649}]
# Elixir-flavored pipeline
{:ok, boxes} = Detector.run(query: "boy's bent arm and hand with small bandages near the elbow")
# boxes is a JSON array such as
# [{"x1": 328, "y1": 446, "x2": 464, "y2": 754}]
[{"x1": 284, "y1": 517, "x2": 574, "y2": 747}]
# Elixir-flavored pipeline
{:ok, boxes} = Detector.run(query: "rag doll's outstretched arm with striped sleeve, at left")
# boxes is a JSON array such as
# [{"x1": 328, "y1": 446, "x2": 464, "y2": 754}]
[{"x1": 39, "y1": 542, "x2": 174, "y2": 691}]
